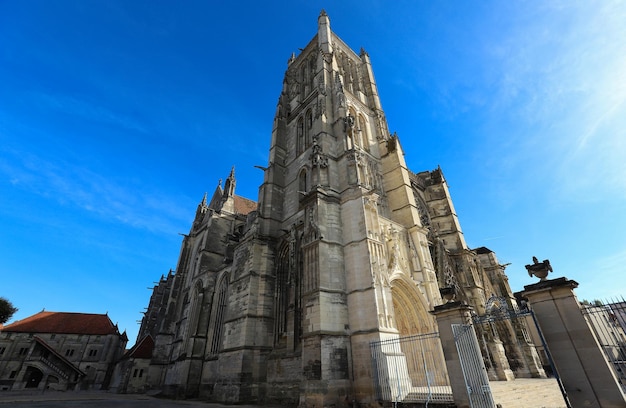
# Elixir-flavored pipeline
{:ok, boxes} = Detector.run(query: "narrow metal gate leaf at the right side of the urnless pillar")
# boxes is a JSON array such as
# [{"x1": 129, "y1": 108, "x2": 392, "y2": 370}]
[{"x1": 452, "y1": 324, "x2": 496, "y2": 408}]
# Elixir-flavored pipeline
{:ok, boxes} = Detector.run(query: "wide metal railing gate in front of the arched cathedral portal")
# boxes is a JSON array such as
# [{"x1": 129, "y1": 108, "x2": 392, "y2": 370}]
[{"x1": 370, "y1": 333, "x2": 453, "y2": 403}]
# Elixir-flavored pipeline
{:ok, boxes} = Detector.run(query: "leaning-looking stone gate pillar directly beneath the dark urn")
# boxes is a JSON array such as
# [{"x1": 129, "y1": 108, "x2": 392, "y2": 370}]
[{"x1": 522, "y1": 278, "x2": 626, "y2": 408}]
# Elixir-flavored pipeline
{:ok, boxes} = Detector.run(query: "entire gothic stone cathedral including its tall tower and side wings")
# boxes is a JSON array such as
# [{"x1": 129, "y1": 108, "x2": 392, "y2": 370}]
[{"x1": 127, "y1": 12, "x2": 536, "y2": 406}]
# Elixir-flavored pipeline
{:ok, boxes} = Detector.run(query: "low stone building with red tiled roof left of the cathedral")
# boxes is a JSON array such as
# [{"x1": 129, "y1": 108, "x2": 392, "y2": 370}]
[{"x1": 0, "y1": 311, "x2": 128, "y2": 391}]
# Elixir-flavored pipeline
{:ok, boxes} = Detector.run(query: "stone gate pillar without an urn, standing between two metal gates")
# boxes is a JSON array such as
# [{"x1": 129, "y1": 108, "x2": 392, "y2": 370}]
[{"x1": 431, "y1": 302, "x2": 494, "y2": 408}]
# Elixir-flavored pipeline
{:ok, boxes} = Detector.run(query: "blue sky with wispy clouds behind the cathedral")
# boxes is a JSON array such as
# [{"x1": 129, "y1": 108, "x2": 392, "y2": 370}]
[{"x1": 0, "y1": 0, "x2": 626, "y2": 344}]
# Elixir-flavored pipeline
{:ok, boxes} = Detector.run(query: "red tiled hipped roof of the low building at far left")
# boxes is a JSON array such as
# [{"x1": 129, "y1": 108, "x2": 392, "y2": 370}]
[{"x1": 1, "y1": 312, "x2": 119, "y2": 335}]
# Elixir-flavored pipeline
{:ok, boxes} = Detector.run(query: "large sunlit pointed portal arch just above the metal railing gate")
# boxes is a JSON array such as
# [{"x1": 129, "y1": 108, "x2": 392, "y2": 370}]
[{"x1": 391, "y1": 275, "x2": 436, "y2": 336}]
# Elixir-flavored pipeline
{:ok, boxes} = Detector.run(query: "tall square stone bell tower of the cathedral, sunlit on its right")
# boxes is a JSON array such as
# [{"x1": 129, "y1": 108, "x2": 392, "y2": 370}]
[{"x1": 258, "y1": 11, "x2": 441, "y2": 406}]
